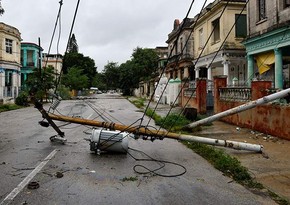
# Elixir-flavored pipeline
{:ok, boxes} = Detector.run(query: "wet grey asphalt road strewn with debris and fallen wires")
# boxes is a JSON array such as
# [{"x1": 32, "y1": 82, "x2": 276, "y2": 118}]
[{"x1": 0, "y1": 94, "x2": 275, "y2": 205}]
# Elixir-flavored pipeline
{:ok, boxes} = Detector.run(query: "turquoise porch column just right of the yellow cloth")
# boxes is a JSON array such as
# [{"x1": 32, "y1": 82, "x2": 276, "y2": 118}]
[{"x1": 274, "y1": 48, "x2": 283, "y2": 89}]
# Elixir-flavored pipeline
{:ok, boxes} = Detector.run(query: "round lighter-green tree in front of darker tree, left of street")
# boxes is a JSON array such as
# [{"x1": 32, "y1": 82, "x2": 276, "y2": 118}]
[{"x1": 62, "y1": 66, "x2": 88, "y2": 90}]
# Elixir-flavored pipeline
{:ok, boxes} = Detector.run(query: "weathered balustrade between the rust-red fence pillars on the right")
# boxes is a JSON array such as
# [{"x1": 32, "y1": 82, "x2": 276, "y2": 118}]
[{"x1": 219, "y1": 87, "x2": 252, "y2": 102}]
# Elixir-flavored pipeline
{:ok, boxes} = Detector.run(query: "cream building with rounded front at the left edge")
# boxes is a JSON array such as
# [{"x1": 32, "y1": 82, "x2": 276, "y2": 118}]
[{"x1": 0, "y1": 22, "x2": 21, "y2": 104}]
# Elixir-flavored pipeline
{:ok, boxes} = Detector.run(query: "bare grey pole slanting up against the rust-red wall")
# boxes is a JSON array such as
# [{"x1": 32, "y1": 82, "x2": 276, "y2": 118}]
[{"x1": 186, "y1": 88, "x2": 290, "y2": 128}]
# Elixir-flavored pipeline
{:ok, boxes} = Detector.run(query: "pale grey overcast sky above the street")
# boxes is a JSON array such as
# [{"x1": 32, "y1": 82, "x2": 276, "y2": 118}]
[{"x1": 0, "y1": 0, "x2": 212, "y2": 72}]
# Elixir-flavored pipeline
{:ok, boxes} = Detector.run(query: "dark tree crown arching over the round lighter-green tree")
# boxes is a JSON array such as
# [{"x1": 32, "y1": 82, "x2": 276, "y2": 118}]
[{"x1": 62, "y1": 52, "x2": 97, "y2": 88}]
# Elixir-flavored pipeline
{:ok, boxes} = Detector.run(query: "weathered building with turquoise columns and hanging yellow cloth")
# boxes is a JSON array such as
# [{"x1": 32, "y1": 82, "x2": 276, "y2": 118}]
[{"x1": 244, "y1": 0, "x2": 290, "y2": 89}]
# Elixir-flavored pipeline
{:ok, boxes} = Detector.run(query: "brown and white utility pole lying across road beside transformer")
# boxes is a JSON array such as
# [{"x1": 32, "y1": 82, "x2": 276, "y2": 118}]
[{"x1": 48, "y1": 114, "x2": 263, "y2": 152}]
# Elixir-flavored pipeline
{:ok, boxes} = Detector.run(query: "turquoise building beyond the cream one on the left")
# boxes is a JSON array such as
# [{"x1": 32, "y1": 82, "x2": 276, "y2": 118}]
[{"x1": 21, "y1": 42, "x2": 43, "y2": 89}]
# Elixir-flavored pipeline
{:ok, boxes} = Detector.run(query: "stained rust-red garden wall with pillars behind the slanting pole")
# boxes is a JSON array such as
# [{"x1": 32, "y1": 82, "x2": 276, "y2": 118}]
[{"x1": 214, "y1": 76, "x2": 290, "y2": 140}]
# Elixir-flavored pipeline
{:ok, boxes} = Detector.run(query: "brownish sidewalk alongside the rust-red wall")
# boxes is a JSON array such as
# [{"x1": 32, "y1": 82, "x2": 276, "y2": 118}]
[{"x1": 150, "y1": 103, "x2": 290, "y2": 201}]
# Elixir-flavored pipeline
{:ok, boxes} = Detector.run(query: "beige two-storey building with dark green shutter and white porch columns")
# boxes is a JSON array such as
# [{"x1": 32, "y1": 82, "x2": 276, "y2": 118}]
[{"x1": 193, "y1": 0, "x2": 247, "y2": 85}]
